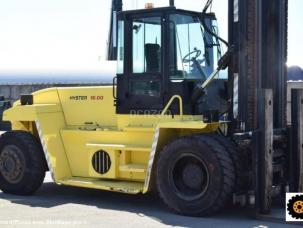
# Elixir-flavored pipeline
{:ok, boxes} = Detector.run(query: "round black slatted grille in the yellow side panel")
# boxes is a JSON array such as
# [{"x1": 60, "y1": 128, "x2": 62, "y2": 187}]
[{"x1": 92, "y1": 150, "x2": 111, "y2": 174}]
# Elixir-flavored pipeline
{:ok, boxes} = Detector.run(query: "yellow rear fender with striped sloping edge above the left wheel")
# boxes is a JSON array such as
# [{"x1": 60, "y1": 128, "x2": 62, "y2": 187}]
[{"x1": 3, "y1": 102, "x2": 71, "y2": 182}]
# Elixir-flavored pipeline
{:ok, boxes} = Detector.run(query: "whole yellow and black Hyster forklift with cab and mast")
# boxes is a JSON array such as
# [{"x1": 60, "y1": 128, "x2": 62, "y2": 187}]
[{"x1": 0, "y1": 0, "x2": 303, "y2": 216}]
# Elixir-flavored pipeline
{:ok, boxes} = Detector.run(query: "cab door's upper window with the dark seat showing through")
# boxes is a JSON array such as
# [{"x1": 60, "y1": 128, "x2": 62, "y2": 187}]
[{"x1": 132, "y1": 17, "x2": 161, "y2": 73}]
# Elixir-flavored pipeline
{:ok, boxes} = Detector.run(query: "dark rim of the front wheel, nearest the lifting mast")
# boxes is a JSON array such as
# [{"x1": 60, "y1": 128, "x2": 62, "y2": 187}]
[{"x1": 169, "y1": 153, "x2": 209, "y2": 200}]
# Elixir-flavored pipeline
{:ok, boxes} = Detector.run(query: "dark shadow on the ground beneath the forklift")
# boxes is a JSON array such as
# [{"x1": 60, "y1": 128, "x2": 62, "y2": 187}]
[{"x1": 0, "y1": 182, "x2": 296, "y2": 227}]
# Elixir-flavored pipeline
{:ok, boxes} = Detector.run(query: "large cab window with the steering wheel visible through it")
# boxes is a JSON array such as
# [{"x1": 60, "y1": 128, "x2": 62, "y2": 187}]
[{"x1": 169, "y1": 14, "x2": 220, "y2": 80}]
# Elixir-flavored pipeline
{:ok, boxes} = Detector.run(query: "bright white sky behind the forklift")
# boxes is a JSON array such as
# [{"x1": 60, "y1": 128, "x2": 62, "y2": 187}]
[{"x1": 0, "y1": 0, "x2": 303, "y2": 71}]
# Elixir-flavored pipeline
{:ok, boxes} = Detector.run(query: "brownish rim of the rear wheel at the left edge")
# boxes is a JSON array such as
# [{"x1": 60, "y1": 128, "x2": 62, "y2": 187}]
[{"x1": 0, "y1": 145, "x2": 25, "y2": 184}]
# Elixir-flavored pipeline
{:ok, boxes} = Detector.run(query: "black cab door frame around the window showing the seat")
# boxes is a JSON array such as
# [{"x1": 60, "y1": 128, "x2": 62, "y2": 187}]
[{"x1": 116, "y1": 11, "x2": 167, "y2": 115}]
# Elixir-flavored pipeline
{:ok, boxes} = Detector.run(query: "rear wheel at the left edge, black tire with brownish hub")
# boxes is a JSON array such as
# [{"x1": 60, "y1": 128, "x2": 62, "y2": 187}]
[{"x1": 0, "y1": 131, "x2": 46, "y2": 195}]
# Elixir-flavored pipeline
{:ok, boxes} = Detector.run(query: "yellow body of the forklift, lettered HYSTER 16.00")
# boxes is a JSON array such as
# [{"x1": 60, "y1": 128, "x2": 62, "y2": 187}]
[{"x1": 3, "y1": 86, "x2": 219, "y2": 193}]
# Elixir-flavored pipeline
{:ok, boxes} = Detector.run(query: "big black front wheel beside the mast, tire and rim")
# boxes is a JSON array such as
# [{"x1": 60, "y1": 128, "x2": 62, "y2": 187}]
[{"x1": 157, "y1": 135, "x2": 235, "y2": 216}]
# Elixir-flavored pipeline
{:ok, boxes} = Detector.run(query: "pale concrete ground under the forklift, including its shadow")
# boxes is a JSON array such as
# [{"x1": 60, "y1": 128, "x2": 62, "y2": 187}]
[{"x1": 0, "y1": 174, "x2": 298, "y2": 228}]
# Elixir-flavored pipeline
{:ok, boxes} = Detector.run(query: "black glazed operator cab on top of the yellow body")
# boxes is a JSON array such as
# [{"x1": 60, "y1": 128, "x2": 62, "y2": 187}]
[{"x1": 114, "y1": 7, "x2": 225, "y2": 115}]
